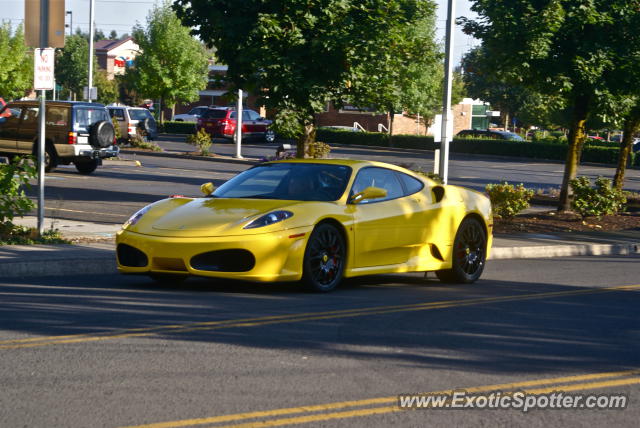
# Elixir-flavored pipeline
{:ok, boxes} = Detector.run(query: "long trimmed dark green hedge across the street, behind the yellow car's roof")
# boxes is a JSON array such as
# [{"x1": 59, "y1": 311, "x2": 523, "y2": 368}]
[{"x1": 316, "y1": 128, "x2": 640, "y2": 166}]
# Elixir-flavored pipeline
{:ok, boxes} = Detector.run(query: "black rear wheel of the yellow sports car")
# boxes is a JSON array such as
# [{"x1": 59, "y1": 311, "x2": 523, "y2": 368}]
[{"x1": 436, "y1": 217, "x2": 487, "y2": 284}]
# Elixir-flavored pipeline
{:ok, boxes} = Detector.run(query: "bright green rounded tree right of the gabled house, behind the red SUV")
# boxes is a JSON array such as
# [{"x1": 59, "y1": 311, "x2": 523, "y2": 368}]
[{"x1": 133, "y1": 3, "x2": 208, "y2": 121}]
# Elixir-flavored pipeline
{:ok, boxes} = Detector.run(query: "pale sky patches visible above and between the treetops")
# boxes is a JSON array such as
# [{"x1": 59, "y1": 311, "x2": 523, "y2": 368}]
[{"x1": 0, "y1": 0, "x2": 479, "y2": 64}]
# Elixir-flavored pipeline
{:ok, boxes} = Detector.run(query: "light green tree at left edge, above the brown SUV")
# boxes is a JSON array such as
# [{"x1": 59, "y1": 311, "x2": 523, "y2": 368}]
[{"x1": 0, "y1": 22, "x2": 33, "y2": 100}]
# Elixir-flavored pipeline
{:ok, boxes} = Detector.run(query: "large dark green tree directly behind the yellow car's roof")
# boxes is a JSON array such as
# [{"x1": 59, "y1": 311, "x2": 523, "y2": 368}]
[{"x1": 178, "y1": 0, "x2": 442, "y2": 157}]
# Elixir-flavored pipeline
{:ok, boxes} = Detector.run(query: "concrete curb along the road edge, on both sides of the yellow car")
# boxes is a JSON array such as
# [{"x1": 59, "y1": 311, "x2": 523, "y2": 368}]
[{"x1": 0, "y1": 243, "x2": 640, "y2": 279}]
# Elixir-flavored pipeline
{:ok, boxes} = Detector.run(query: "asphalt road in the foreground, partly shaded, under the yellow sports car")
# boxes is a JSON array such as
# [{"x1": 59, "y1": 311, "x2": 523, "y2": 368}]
[{"x1": 0, "y1": 256, "x2": 640, "y2": 428}]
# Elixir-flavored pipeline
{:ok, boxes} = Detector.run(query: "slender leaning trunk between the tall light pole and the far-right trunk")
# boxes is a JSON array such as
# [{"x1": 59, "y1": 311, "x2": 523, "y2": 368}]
[{"x1": 558, "y1": 96, "x2": 589, "y2": 211}]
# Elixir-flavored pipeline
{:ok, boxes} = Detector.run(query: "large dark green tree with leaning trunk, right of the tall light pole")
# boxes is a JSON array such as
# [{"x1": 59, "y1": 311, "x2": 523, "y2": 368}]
[{"x1": 462, "y1": 0, "x2": 637, "y2": 210}]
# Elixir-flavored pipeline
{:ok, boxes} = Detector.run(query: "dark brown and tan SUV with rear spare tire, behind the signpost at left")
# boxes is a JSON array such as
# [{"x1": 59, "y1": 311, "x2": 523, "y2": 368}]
[{"x1": 0, "y1": 101, "x2": 119, "y2": 174}]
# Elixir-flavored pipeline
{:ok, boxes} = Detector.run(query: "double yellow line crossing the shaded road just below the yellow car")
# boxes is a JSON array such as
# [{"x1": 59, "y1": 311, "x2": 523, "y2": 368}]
[{"x1": 0, "y1": 285, "x2": 640, "y2": 349}]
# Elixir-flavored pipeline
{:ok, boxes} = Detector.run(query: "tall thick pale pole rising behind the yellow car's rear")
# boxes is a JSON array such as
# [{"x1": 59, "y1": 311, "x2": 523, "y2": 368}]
[{"x1": 436, "y1": 0, "x2": 456, "y2": 184}]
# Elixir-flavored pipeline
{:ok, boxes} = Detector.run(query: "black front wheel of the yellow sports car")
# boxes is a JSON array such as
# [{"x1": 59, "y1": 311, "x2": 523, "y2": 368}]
[{"x1": 302, "y1": 223, "x2": 347, "y2": 293}]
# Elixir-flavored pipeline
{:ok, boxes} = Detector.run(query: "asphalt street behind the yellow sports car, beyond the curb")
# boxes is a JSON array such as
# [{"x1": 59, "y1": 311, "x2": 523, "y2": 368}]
[{"x1": 22, "y1": 137, "x2": 640, "y2": 223}]
